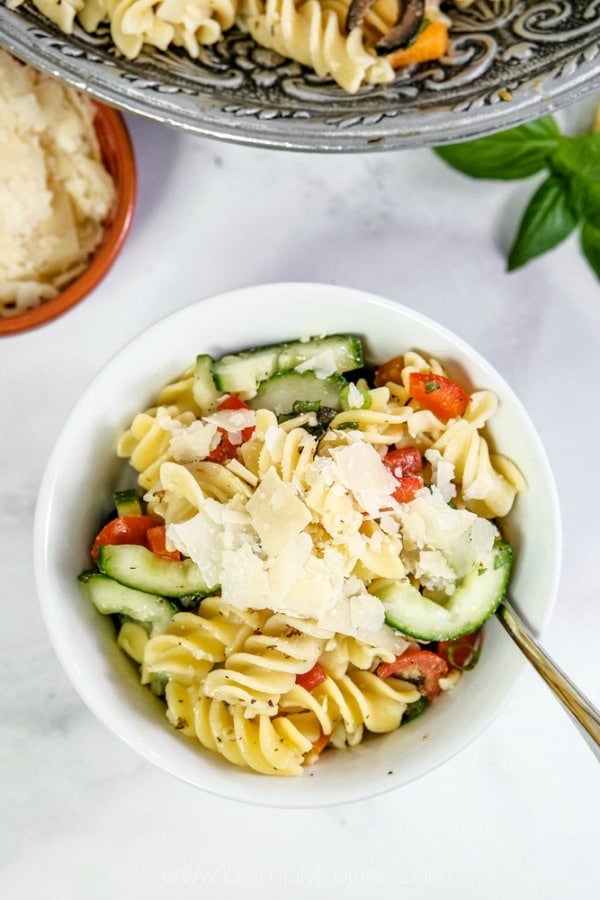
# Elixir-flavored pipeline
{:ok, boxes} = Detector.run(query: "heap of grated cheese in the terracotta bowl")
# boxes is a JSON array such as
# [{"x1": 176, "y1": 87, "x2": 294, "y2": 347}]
[{"x1": 0, "y1": 50, "x2": 115, "y2": 316}]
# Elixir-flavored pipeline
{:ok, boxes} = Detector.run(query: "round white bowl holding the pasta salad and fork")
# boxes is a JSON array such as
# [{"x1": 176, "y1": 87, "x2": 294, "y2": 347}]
[{"x1": 35, "y1": 284, "x2": 561, "y2": 807}]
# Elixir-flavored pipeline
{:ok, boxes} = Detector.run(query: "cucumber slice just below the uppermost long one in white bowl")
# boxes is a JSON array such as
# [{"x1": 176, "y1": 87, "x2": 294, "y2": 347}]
[{"x1": 248, "y1": 369, "x2": 348, "y2": 416}]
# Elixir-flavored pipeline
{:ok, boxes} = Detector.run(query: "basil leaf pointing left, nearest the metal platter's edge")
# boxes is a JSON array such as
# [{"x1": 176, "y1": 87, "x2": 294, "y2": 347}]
[{"x1": 434, "y1": 116, "x2": 564, "y2": 180}]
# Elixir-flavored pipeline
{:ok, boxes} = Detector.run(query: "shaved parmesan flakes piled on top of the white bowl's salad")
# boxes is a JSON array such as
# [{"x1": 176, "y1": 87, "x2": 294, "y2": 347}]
[{"x1": 161, "y1": 410, "x2": 497, "y2": 652}]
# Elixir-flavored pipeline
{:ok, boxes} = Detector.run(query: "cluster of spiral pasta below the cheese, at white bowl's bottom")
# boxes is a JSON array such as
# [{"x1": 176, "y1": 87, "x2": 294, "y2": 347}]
[{"x1": 142, "y1": 598, "x2": 420, "y2": 775}]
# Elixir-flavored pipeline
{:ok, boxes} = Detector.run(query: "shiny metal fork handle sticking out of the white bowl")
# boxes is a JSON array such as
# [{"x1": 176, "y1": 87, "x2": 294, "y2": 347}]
[{"x1": 496, "y1": 600, "x2": 600, "y2": 759}]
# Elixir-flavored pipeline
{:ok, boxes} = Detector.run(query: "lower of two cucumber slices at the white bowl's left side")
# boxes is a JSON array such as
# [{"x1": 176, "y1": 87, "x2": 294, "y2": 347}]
[{"x1": 78, "y1": 571, "x2": 178, "y2": 636}]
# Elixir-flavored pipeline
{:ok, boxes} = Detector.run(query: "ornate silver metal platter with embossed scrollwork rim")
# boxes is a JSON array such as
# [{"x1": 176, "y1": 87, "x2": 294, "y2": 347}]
[{"x1": 0, "y1": 0, "x2": 600, "y2": 152}]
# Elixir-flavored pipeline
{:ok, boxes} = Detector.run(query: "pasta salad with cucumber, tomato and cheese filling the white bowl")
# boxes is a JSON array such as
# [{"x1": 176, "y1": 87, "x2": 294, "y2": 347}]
[{"x1": 79, "y1": 335, "x2": 526, "y2": 776}]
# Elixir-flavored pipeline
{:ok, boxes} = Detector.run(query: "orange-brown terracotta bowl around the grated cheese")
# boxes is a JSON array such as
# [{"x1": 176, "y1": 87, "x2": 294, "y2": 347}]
[{"x1": 0, "y1": 103, "x2": 137, "y2": 335}]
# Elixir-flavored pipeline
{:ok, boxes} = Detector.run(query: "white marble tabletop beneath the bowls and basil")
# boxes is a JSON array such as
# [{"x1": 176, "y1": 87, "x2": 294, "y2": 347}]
[{"x1": 0, "y1": 107, "x2": 600, "y2": 900}]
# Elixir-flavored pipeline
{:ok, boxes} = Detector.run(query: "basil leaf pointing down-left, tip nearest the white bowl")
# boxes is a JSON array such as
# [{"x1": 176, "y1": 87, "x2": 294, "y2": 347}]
[{"x1": 508, "y1": 175, "x2": 578, "y2": 272}]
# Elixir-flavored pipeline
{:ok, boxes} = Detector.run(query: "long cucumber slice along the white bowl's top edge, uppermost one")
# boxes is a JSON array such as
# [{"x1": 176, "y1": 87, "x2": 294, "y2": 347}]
[{"x1": 213, "y1": 334, "x2": 363, "y2": 400}]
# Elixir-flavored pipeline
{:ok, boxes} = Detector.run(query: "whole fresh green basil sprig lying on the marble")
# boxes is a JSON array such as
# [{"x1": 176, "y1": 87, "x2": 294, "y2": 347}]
[{"x1": 435, "y1": 116, "x2": 600, "y2": 278}]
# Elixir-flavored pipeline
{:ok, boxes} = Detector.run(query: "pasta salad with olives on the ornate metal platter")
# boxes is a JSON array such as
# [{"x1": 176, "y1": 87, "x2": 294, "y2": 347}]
[{"x1": 7, "y1": 0, "x2": 474, "y2": 93}]
